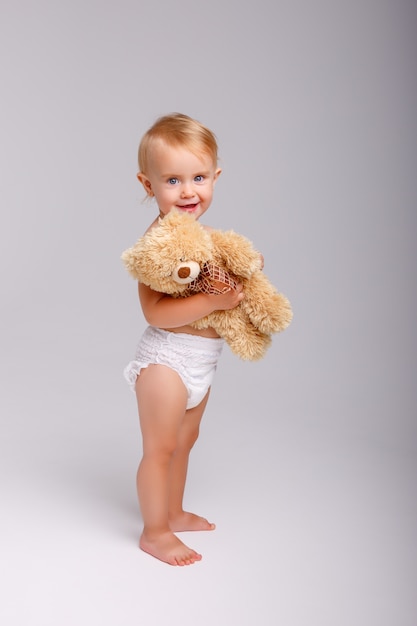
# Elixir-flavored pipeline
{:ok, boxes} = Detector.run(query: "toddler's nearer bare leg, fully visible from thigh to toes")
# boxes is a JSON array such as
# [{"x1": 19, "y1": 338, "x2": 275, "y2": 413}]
[{"x1": 136, "y1": 365, "x2": 201, "y2": 565}]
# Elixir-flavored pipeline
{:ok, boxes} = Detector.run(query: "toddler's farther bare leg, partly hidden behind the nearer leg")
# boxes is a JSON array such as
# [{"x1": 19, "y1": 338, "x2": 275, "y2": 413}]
[{"x1": 169, "y1": 391, "x2": 215, "y2": 532}]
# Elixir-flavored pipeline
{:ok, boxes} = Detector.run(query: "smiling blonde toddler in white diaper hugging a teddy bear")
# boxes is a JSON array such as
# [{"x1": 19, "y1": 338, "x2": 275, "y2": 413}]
[{"x1": 125, "y1": 114, "x2": 244, "y2": 565}]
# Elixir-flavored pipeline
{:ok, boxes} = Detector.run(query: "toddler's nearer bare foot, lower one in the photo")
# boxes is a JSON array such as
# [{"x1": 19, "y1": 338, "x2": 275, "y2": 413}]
[{"x1": 139, "y1": 532, "x2": 202, "y2": 565}]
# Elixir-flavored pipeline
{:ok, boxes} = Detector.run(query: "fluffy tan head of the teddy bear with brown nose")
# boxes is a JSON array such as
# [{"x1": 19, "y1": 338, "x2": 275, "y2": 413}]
[{"x1": 122, "y1": 210, "x2": 213, "y2": 295}]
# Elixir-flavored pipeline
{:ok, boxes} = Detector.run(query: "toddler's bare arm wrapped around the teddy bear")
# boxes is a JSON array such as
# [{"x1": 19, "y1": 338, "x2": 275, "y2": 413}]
[{"x1": 138, "y1": 283, "x2": 244, "y2": 328}]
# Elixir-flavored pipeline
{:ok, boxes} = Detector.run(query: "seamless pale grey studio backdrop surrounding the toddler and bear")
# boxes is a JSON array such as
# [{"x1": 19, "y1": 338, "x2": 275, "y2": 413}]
[{"x1": 0, "y1": 0, "x2": 417, "y2": 626}]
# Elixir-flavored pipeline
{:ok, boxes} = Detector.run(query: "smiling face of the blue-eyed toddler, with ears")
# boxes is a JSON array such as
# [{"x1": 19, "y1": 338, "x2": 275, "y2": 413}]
[{"x1": 138, "y1": 140, "x2": 221, "y2": 219}]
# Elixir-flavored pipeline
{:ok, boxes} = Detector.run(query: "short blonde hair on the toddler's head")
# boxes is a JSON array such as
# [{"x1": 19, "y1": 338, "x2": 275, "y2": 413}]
[{"x1": 138, "y1": 113, "x2": 218, "y2": 174}]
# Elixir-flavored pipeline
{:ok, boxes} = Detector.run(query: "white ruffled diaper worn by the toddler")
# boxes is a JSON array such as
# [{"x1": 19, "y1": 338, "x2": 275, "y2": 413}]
[{"x1": 123, "y1": 326, "x2": 224, "y2": 409}]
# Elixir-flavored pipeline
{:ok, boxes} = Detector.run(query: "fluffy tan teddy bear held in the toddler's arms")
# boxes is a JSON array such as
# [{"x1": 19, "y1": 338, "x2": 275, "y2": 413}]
[{"x1": 122, "y1": 209, "x2": 292, "y2": 361}]
